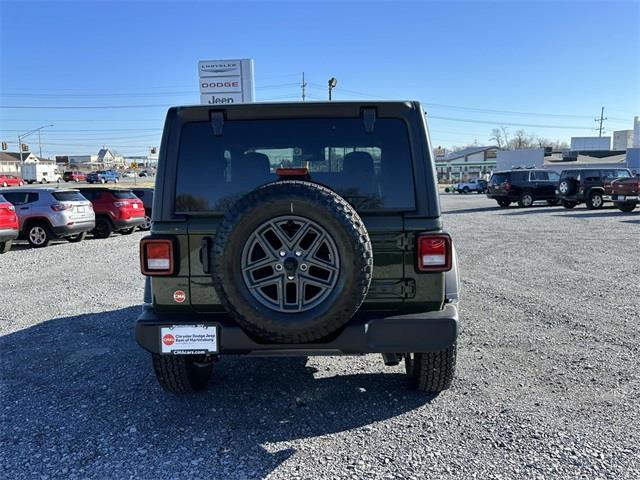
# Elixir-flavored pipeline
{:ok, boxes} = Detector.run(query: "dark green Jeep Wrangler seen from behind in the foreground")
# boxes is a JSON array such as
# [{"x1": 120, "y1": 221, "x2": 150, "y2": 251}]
[{"x1": 136, "y1": 102, "x2": 458, "y2": 393}]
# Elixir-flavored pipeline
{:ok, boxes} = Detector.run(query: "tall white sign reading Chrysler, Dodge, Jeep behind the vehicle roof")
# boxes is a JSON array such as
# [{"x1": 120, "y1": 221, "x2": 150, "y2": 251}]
[{"x1": 198, "y1": 59, "x2": 254, "y2": 105}]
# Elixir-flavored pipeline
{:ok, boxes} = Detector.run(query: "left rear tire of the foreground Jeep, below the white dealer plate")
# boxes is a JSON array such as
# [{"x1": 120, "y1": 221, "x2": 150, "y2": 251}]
[{"x1": 151, "y1": 353, "x2": 213, "y2": 395}]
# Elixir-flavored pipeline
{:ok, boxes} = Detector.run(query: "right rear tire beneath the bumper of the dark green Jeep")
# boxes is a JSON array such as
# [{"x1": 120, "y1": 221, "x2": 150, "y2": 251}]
[{"x1": 404, "y1": 343, "x2": 457, "y2": 393}]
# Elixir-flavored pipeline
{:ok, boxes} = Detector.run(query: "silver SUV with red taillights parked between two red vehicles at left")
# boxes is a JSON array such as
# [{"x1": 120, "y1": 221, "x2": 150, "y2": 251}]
[{"x1": 2, "y1": 188, "x2": 96, "y2": 247}]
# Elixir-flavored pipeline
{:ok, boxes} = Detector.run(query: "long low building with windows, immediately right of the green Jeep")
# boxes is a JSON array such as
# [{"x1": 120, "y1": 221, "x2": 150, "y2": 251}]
[{"x1": 436, "y1": 145, "x2": 499, "y2": 182}]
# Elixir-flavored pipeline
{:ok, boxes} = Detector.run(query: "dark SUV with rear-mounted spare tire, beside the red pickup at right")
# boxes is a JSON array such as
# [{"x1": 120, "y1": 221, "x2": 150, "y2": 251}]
[{"x1": 556, "y1": 168, "x2": 632, "y2": 209}]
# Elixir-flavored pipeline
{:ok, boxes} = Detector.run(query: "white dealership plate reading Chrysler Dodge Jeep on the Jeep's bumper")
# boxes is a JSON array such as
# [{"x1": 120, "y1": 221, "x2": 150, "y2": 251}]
[{"x1": 160, "y1": 325, "x2": 218, "y2": 355}]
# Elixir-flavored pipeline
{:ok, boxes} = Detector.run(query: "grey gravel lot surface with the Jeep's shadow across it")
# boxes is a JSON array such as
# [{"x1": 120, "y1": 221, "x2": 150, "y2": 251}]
[{"x1": 0, "y1": 195, "x2": 640, "y2": 479}]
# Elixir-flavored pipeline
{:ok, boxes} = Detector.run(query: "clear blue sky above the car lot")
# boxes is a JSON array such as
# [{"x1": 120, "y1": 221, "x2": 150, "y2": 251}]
[{"x1": 0, "y1": 0, "x2": 640, "y2": 156}]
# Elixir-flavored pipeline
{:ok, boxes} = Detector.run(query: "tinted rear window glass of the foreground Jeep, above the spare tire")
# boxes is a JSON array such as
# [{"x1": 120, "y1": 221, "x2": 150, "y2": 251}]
[{"x1": 175, "y1": 118, "x2": 415, "y2": 212}]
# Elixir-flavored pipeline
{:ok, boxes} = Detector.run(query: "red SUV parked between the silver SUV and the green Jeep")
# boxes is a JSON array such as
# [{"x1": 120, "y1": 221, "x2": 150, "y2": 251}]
[{"x1": 79, "y1": 187, "x2": 145, "y2": 238}]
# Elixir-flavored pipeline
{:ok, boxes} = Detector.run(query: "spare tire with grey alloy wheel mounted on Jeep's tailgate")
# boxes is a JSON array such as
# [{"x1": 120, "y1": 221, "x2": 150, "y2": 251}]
[{"x1": 211, "y1": 180, "x2": 373, "y2": 343}]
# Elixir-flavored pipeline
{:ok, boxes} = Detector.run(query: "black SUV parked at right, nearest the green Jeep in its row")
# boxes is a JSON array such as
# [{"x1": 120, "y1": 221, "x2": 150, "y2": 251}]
[{"x1": 487, "y1": 169, "x2": 560, "y2": 208}]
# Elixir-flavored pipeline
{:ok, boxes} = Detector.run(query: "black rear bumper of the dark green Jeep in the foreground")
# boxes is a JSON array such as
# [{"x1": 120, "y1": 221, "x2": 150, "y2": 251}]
[{"x1": 135, "y1": 304, "x2": 458, "y2": 356}]
